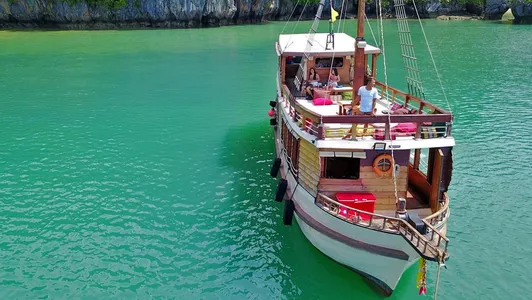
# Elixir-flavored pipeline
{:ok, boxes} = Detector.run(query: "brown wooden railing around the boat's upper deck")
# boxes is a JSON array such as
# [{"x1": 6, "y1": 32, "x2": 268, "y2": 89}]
[{"x1": 281, "y1": 83, "x2": 452, "y2": 140}]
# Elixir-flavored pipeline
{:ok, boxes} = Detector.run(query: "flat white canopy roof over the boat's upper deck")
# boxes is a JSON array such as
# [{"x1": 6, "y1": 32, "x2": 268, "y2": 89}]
[{"x1": 279, "y1": 33, "x2": 380, "y2": 56}]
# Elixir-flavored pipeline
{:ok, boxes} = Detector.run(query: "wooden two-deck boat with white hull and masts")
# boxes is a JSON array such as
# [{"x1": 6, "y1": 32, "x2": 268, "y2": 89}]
[{"x1": 270, "y1": 0, "x2": 455, "y2": 295}]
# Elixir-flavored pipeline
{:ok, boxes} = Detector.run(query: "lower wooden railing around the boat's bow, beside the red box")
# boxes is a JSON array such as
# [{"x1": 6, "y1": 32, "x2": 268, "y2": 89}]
[{"x1": 315, "y1": 193, "x2": 449, "y2": 261}]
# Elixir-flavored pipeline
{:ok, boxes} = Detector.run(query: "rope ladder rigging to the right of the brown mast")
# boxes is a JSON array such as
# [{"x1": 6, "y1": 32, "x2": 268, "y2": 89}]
[{"x1": 393, "y1": 0, "x2": 425, "y2": 99}]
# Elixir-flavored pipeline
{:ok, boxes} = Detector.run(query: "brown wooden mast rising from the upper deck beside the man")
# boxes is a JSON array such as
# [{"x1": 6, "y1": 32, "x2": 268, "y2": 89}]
[{"x1": 352, "y1": 0, "x2": 366, "y2": 106}]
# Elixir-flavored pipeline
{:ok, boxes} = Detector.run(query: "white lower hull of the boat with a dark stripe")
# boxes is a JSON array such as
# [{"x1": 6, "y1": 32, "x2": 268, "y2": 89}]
[{"x1": 276, "y1": 127, "x2": 420, "y2": 295}]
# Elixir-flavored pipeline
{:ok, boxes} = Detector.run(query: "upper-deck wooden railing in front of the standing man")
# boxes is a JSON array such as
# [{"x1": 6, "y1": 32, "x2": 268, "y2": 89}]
[{"x1": 281, "y1": 85, "x2": 452, "y2": 140}]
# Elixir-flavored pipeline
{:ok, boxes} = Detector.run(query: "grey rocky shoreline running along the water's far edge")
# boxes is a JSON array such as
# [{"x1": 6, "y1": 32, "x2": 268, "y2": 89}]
[{"x1": 0, "y1": 0, "x2": 532, "y2": 30}]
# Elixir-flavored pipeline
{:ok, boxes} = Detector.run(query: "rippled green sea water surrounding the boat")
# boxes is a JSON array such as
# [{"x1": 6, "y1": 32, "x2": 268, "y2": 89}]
[{"x1": 0, "y1": 20, "x2": 532, "y2": 300}]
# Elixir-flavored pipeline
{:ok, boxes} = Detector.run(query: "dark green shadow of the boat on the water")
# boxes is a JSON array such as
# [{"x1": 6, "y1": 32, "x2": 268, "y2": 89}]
[{"x1": 220, "y1": 120, "x2": 417, "y2": 299}]
